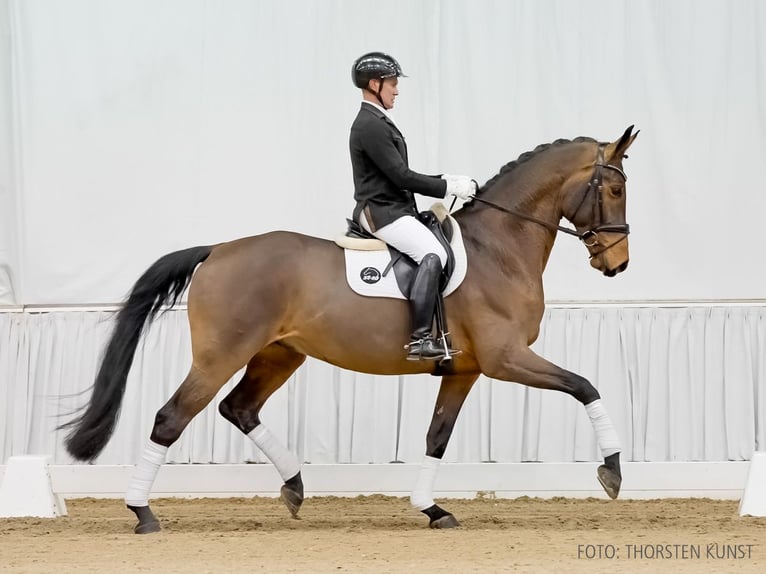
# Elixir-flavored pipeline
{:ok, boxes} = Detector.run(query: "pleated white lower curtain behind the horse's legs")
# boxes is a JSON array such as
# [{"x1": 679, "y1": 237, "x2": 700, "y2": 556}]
[{"x1": 0, "y1": 306, "x2": 766, "y2": 464}]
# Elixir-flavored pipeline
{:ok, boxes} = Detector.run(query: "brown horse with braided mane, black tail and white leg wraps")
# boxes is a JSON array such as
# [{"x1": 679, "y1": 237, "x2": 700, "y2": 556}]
[{"x1": 62, "y1": 126, "x2": 638, "y2": 533}]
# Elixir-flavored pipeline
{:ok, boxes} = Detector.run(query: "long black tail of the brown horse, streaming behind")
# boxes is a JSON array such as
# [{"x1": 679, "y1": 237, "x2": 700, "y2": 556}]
[{"x1": 62, "y1": 246, "x2": 213, "y2": 460}]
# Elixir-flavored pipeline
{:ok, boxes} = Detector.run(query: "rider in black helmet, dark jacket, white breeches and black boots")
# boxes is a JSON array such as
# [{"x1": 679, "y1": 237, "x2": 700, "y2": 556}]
[{"x1": 349, "y1": 52, "x2": 476, "y2": 360}]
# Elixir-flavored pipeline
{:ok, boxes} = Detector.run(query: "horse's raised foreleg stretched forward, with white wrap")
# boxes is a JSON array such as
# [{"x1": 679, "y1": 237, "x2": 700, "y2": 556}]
[{"x1": 482, "y1": 347, "x2": 622, "y2": 498}]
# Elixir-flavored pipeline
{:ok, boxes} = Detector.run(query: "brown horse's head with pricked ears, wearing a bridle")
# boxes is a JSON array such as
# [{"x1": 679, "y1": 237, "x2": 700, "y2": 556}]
[{"x1": 562, "y1": 126, "x2": 638, "y2": 277}]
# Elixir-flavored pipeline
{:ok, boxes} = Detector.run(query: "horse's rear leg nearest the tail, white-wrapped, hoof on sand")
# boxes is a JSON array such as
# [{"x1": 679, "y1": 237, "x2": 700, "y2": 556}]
[{"x1": 125, "y1": 366, "x2": 237, "y2": 534}]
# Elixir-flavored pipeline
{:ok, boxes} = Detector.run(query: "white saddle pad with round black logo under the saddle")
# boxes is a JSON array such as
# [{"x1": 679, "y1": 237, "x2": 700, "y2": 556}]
[{"x1": 344, "y1": 217, "x2": 468, "y2": 299}]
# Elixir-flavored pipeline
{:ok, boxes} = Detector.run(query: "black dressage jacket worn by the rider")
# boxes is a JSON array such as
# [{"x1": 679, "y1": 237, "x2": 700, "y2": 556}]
[{"x1": 349, "y1": 102, "x2": 447, "y2": 231}]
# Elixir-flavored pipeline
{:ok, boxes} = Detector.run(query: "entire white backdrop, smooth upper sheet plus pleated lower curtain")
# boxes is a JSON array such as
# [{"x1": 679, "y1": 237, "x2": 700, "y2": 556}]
[{"x1": 0, "y1": 0, "x2": 766, "y2": 470}]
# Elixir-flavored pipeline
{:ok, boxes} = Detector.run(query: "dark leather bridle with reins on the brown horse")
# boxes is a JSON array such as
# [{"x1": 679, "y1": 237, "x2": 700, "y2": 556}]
[{"x1": 471, "y1": 143, "x2": 630, "y2": 258}]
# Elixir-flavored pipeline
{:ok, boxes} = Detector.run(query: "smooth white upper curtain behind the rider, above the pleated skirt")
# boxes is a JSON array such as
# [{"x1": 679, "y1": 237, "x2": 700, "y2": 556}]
[{"x1": 0, "y1": 0, "x2": 766, "y2": 305}]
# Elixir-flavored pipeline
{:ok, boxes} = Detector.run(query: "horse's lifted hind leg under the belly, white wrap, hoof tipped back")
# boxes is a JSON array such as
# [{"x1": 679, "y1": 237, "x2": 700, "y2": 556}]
[{"x1": 218, "y1": 343, "x2": 306, "y2": 518}]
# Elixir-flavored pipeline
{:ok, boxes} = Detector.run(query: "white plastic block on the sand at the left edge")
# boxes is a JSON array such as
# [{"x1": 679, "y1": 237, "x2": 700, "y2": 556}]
[{"x1": 0, "y1": 455, "x2": 67, "y2": 518}]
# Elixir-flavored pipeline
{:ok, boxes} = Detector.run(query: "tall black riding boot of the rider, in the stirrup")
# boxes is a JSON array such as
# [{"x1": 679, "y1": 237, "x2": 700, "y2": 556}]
[{"x1": 405, "y1": 253, "x2": 444, "y2": 361}]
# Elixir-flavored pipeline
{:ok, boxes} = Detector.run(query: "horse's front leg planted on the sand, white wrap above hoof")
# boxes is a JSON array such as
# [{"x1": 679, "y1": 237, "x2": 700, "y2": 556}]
[{"x1": 410, "y1": 375, "x2": 478, "y2": 528}]
